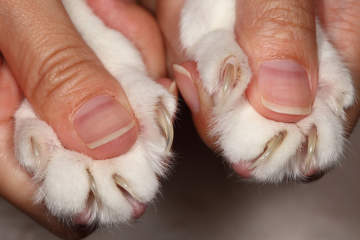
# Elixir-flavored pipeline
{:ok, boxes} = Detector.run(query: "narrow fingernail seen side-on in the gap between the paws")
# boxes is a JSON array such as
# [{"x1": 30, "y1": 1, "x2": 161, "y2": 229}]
[{"x1": 173, "y1": 64, "x2": 200, "y2": 113}]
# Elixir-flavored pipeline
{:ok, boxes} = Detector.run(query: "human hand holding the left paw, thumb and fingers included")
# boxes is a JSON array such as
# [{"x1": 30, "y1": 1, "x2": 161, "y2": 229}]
[{"x1": 0, "y1": 0, "x2": 170, "y2": 238}]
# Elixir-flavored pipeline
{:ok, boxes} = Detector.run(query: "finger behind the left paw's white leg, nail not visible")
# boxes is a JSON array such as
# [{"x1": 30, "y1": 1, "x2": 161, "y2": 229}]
[{"x1": 88, "y1": 0, "x2": 166, "y2": 79}]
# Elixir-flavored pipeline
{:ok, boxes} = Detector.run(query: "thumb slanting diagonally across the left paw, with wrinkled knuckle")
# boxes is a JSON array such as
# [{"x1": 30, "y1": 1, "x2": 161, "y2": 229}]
[{"x1": 0, "y1": 0, "x2": 138, "y2": 159}]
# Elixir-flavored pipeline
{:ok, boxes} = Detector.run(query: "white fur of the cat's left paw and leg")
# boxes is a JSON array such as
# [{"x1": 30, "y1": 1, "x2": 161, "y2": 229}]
[{"x1": 14, "y1": 0, "x2": 176, "y2": 225}]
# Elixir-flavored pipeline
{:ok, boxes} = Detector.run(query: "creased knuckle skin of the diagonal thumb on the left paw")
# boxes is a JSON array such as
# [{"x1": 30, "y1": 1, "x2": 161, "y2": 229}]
[{"x1": 27, "y1": 40, "x2": 98, "y2": 107}]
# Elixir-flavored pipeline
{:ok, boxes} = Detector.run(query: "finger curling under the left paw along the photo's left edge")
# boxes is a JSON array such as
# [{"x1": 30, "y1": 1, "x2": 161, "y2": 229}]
[{"x1": 0, "y1": 63, "x2": 91, "y2": 239}]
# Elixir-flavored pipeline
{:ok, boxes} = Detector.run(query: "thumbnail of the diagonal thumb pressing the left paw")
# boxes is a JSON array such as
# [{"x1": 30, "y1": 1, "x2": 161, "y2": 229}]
[{"x1": 74, "y1": 96, "x2": 135, "y2": 149}]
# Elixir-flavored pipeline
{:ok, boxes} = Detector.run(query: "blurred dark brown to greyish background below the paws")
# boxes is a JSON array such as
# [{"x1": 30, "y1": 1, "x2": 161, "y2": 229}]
[{"x1": 0, "y1": 109, "x2": 360, "y2": 240}]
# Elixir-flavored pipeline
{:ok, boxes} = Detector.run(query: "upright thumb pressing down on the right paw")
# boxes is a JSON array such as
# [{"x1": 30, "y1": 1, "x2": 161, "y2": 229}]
[{"x1": 235, "y1": 0, "x2": 318, "y2": 122}]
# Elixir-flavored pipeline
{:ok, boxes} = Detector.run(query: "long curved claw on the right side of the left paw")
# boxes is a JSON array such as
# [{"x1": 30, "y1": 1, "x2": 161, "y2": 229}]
[{"x1": 157, "y1": 102, "x2": 174, "y2": 152}]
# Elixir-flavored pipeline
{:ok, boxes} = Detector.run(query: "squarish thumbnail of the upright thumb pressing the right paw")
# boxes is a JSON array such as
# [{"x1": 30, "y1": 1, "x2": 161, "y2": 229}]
[{"x1": 258, "y1": 60, "x2": 313, "y2": 115}]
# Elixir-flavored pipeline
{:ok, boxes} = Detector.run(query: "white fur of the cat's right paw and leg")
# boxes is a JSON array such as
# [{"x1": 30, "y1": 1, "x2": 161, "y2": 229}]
[{"x1": 180, "y1": 0, "x2": 354, "y2": 182}]
